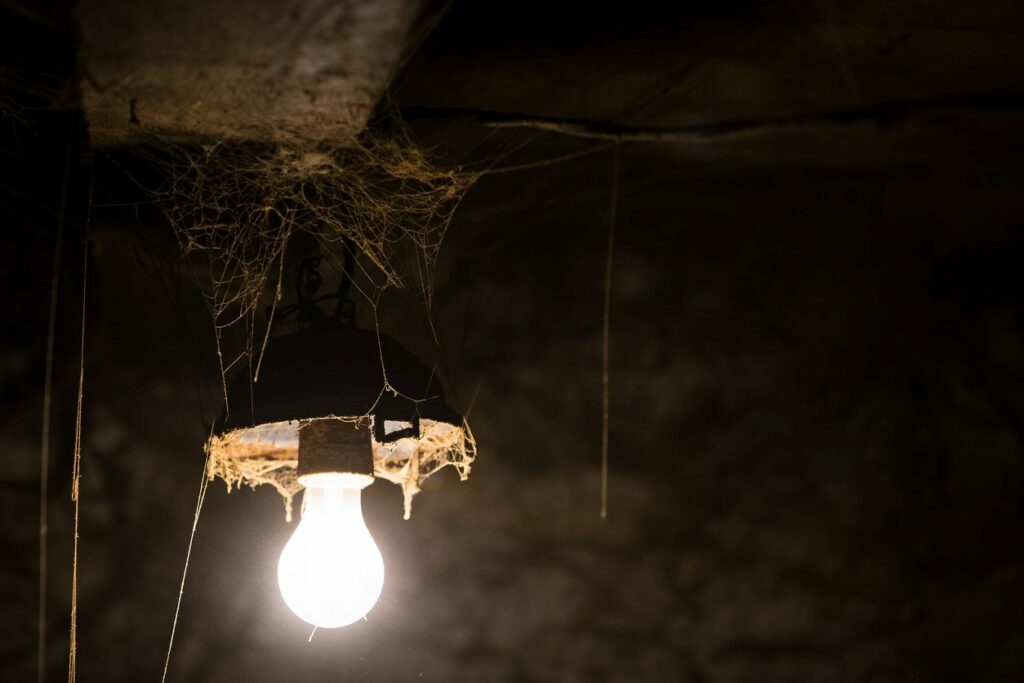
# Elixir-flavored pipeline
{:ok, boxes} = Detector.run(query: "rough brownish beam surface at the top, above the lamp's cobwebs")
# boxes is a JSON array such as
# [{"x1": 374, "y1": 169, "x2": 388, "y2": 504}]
[{"x1": 80, "y1": 0, "x2": 419, "y2": 146}]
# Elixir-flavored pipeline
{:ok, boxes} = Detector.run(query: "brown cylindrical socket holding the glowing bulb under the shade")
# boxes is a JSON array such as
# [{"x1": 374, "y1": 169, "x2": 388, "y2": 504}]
[{"x1": 296, "y1": 418, "x2": 374, "y2": 485}]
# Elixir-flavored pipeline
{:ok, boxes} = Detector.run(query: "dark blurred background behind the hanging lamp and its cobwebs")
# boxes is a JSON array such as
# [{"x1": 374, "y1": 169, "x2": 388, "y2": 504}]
[{"x1": 0, "y1": 0, "x2": 1024, "y2": 682}]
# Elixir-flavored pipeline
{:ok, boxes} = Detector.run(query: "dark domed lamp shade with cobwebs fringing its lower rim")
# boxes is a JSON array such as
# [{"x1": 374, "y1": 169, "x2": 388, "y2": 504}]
[{"x1": 206, "y1": 325, "x2": 476, "y2": 518}]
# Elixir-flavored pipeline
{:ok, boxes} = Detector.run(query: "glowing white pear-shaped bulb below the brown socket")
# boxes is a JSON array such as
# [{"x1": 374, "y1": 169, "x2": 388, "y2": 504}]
[{"x1": 278, "y1": 472, "x2": 384, "y2": 629}]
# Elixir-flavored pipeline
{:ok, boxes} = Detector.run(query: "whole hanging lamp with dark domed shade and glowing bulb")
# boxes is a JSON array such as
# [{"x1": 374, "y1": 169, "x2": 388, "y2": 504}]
[{"x1": 207, "y1": 244, "x2": 475, "y2": 628}]
